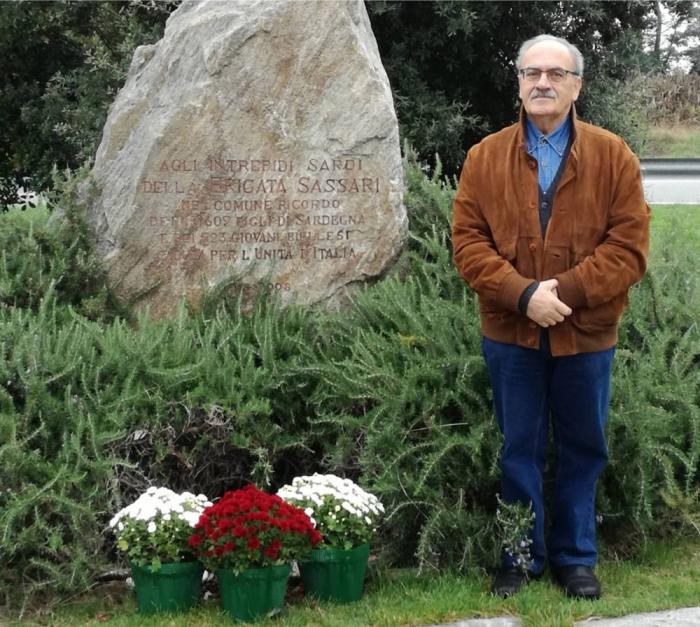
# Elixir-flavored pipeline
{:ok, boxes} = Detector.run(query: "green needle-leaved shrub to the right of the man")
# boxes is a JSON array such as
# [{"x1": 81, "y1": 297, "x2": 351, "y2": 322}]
[{"x1": 600, "y1": 223, "x2": 700, "y2": 548}]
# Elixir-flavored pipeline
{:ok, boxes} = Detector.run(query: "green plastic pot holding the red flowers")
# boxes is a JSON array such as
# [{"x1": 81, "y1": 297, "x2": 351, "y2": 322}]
[{"x1": 216, "y1": 564, "x2": 291, "y2": 623}]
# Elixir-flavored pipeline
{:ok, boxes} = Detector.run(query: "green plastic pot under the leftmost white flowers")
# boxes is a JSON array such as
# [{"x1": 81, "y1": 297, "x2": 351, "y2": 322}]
[{"x1": 131, "y1": 562, "x2": 204, "y2": 614}]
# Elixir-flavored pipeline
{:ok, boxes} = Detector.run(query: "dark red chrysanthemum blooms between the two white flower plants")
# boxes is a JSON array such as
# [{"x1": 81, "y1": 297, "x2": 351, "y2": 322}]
[{"x1": 189, "y1": 485, "x2": 321, "y2": 573}]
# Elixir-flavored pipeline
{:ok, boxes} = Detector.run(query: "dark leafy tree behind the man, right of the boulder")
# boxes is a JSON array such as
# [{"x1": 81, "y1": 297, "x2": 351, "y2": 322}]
[{"x1": 367, "y1": 0, "x2": 654, "y2": 173}]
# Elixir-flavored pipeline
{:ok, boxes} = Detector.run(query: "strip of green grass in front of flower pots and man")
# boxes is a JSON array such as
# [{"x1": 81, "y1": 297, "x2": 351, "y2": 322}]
[{"x1": 9, "y1": 537, "x2": 700, "y2": 627}]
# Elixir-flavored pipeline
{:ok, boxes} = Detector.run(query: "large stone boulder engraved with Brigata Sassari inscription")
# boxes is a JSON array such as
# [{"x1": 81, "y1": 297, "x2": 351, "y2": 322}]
[{"x1": 89, "y1": 0, "x2": 407, "y2": 316}]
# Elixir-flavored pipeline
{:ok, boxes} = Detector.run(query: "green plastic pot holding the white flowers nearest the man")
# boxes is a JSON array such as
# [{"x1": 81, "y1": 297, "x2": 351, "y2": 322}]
[{"x1": 299, "y1": 544, "x2": 369, "y2": 603}]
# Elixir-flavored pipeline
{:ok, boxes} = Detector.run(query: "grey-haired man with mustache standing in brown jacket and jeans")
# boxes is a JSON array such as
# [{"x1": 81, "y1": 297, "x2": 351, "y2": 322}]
[{"x1": 452, "y1": 35, "x2": 649, "y2": 598}]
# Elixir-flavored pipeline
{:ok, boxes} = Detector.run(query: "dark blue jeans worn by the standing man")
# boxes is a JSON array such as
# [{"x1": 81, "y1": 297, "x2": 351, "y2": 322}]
[{"x1": 482, "y1": 332, "x2": 615, "y2": 573}]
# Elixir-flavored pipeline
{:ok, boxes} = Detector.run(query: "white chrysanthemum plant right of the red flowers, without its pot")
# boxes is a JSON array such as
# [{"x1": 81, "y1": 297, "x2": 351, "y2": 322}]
[{"x1": 277, "y1": 473, "x2": 384, "y2": 550}]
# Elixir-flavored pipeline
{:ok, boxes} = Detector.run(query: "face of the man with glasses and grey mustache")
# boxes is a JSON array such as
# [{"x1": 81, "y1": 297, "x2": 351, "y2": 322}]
[{"x1": 519, "y1": 41, "x2": 581, "y2": 133}]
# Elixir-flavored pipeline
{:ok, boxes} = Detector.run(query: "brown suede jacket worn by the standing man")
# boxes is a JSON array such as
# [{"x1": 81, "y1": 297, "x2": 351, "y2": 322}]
[{"x1": 452, "y1": 108, "x2": 650, "y2": 356}]
